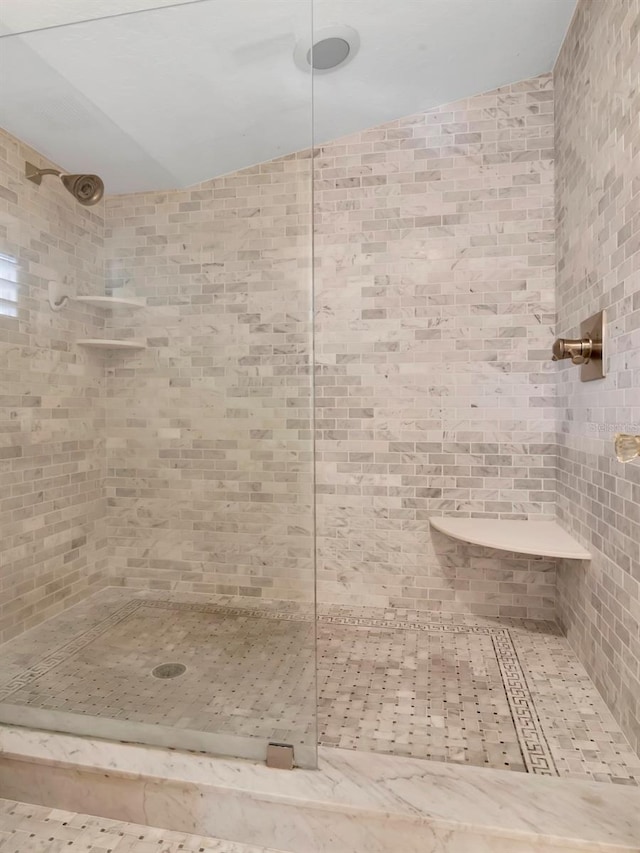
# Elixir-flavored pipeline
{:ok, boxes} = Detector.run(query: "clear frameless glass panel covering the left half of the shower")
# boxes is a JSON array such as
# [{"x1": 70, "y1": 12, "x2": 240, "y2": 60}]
[{"x1": 0, "y1": 0, "x2": 316, "y2": 767}]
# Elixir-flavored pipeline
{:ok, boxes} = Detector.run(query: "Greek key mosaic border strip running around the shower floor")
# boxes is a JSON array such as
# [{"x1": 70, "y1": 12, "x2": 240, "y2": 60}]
[{"x1": 0, "y1": 599, "x2": 559, "y2": 776}]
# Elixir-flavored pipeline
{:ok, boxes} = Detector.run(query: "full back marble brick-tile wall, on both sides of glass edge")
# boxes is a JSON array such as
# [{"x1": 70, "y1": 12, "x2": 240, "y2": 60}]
[{"x1": 106, "y1": 75, "x2": 555, "y2": 618}]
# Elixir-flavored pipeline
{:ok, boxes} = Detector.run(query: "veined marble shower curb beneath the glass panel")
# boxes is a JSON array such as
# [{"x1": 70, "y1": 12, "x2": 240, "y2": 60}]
[{"x1": 0, "y1": 727, "x2": 640, "y2": 853}]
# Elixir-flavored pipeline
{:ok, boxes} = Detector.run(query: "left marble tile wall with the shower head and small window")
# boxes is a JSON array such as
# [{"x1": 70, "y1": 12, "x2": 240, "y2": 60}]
[{"x1": 0, "y1": 126, "x2": 106, "y2": 641}]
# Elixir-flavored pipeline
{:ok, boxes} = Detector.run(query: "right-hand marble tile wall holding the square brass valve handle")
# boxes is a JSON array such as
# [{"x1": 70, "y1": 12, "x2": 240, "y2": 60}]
[{"x1": 555, "y1": 0, "x2": 640, "y2": 749}]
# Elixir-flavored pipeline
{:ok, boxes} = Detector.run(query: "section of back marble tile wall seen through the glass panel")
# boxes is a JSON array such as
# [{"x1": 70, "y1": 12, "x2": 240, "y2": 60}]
[{"x1": 106, "y1": 152, "x2": 314, "y2": 601}]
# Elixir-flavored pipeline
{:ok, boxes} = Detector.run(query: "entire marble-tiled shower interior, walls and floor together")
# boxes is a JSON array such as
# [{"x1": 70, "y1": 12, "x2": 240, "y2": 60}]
[{"x1": 0, "y1": 0, "x2": 640, "y2": 824}]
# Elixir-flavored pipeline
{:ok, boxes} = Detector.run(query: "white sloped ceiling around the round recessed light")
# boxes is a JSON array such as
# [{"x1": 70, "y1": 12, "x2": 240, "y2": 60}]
[{"x1": 0, "y1": 0, "x2": 576, "y2": 193}]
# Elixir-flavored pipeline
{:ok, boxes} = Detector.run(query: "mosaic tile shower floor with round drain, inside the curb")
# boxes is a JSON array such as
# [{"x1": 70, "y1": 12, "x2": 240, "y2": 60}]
[{"x1": 0, "y1": 590, "x2": 640, "y2": 785}]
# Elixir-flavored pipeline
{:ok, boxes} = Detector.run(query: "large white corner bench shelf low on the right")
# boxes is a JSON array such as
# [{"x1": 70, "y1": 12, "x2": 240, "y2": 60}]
[{"x1": 429, "y1": 518, "x2": 591, "y2": 560}]
